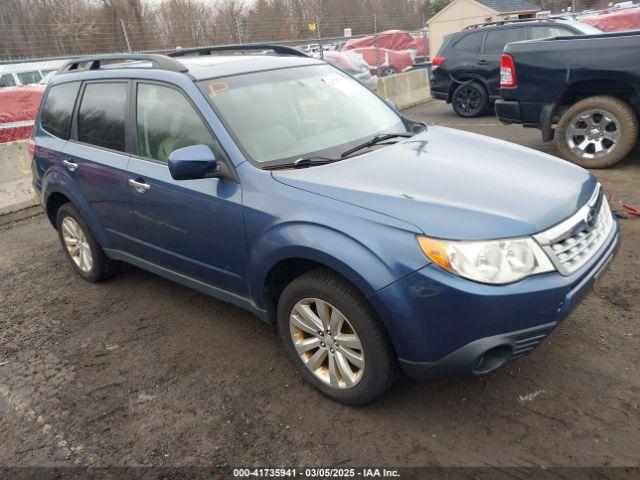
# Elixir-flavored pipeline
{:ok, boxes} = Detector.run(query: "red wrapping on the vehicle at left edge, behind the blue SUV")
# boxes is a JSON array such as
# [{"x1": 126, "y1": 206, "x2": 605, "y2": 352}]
[{"x1": 0, "y1": 85, "x2": 45, "y2": 143}]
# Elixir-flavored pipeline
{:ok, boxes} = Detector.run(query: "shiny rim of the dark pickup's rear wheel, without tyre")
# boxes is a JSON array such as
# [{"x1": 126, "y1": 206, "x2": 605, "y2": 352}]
[{"x1": 565, "y1": 109, "x2": 620, "y2": 159}]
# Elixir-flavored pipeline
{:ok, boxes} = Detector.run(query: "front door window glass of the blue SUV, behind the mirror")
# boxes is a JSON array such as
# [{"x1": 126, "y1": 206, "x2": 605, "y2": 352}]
[{"x1": 136, "y1": 84, "x2": 222, "y2": 163}]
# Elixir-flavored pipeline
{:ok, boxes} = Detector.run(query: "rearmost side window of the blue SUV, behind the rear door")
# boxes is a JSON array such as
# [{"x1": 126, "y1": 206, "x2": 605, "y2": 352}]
[{"x1": 40, "y1": 82, "x2": 80, "y2": 140}]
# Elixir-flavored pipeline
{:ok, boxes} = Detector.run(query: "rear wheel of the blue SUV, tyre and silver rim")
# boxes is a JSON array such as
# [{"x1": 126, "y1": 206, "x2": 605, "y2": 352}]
[{"x1": 56, "y1": 203, "x2": 119, "y2": 282}]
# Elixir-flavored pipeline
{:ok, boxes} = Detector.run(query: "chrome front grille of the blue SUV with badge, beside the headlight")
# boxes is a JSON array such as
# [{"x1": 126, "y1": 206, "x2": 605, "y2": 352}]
[{"x1": 536, "y1": 186, "x2": 614, "y2": 275}]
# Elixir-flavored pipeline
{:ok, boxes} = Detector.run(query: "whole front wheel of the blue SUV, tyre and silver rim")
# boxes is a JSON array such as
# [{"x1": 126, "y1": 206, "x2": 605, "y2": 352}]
[{"x1": 278, "y1": 269, "x2": 395, "y2": 405}]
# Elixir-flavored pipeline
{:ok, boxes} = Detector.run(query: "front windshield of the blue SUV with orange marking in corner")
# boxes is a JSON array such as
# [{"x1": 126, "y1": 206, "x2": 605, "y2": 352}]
[{"x1": 199, "y1": 65, "x2": 407, "y2": 165}]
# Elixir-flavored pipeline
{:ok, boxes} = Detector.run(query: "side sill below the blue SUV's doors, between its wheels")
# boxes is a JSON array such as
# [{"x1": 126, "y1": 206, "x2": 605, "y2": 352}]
[{"x1": 104, "y1": 248, "x2": 272, "y2": 323}]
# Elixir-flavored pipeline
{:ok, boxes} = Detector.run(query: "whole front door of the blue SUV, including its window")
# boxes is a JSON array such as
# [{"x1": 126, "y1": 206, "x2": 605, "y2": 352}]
[{"x1": 129, "y1": 82, "x2": 248, "y2": 295}]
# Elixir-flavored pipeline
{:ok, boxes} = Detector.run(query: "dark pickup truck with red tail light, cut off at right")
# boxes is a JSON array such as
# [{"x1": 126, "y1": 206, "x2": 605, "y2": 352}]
[{"x1": 495, "y1": 30, "x2": 640, "y2": 168}]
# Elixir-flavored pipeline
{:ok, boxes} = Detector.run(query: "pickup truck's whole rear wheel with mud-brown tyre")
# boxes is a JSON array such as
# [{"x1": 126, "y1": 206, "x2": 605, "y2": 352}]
[{"x1": 555, "y1": 96, "x2": 638, "y2": 168}]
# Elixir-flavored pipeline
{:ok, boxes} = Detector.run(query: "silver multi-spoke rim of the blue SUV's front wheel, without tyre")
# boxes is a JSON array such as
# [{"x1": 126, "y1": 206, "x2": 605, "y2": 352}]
[{"x1": 289, "y1": 298, "x2": 365, "y2": 389}]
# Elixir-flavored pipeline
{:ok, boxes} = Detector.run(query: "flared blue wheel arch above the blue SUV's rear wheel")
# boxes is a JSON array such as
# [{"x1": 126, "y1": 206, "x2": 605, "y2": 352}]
[{"x1": 42, "y1": 167, "x2": 110, "y2": 248}]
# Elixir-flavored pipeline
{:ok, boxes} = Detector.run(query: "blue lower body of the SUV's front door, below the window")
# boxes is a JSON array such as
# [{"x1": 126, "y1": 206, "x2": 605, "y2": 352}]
[{"x1": 128, "y1": 157, "x2": 247, "y2": 295}]
